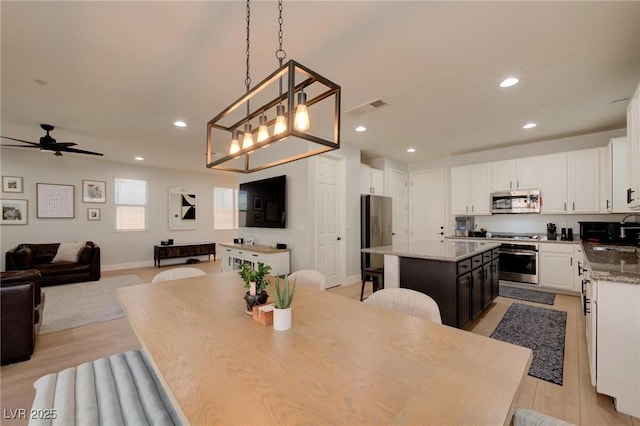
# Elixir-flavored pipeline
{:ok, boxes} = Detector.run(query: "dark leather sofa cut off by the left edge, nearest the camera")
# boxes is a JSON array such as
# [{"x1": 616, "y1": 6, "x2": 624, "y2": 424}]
[{"x1": 0, "y1": 269, "x2": 45, "y2": 364}]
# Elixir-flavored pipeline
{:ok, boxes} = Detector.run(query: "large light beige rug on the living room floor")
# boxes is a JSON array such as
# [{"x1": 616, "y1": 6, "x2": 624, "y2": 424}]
[{"x1": 40, "y1": 275, "x2": 143, "y2": 334}]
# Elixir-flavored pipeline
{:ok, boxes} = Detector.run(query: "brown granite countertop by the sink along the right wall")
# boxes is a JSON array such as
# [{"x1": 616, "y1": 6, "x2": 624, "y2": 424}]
[{"x1": 582, "y1": 243, "x2": 640, "y2": 285}]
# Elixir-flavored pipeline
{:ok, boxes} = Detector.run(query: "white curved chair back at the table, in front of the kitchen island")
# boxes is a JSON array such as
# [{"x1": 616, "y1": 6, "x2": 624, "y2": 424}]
[{"x1": 364, "y1": 288, "x2": 442, "y2": 324}]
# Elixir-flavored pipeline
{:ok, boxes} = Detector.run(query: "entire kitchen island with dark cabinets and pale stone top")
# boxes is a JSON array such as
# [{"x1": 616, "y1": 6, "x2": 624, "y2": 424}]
[{"x1": 362, "y1": 239, "x2": 500, "y2": 328}]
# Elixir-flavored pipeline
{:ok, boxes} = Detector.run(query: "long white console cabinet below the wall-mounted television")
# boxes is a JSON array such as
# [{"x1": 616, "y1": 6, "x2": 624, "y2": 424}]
[{"x1": 218, "y1": 244, "x2": 289, "y2": 275}]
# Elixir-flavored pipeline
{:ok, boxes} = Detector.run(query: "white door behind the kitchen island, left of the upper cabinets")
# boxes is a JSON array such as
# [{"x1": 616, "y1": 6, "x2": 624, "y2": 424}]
[{"x1": 409, "y1": 169, "x2": 447, "y2": 241}]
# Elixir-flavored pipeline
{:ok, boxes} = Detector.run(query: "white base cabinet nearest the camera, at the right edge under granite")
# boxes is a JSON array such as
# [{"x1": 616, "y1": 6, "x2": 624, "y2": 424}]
[{"x1": 587, "y1": 280, "x2": 640, "y2": 417}]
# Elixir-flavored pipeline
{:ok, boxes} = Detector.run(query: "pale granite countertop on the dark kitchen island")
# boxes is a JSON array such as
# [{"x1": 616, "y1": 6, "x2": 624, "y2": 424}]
[{"x1": 362, "y1": 238, "x2": 500, "y2": 262}]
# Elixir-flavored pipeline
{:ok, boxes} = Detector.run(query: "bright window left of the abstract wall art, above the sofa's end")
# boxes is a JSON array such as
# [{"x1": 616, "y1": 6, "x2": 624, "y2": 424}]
[{"x1": 115, "y1": 178, "x2": 147, "y2": 231}]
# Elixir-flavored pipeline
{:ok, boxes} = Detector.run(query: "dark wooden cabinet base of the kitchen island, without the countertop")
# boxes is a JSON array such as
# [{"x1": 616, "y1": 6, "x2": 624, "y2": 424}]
[{"x1": 400, "y1": 249, "x2": 499, "y2": 328}]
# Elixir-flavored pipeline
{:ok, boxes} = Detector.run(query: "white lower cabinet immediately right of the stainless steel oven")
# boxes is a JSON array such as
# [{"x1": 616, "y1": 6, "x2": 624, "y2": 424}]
[{"x1": 538, "y1": 243, "x2": 578, "y2": 292}]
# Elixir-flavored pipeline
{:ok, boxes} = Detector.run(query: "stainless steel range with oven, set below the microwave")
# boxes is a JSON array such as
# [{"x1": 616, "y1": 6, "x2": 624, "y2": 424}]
[{"x1": 492, "y1": 234, "x2": 541, "y2": 285}]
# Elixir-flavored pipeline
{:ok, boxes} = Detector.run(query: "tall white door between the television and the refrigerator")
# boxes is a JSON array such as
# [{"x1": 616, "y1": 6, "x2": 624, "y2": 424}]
[{"x1": 314, "y1": 156, "x2": 347, "y2": 287}]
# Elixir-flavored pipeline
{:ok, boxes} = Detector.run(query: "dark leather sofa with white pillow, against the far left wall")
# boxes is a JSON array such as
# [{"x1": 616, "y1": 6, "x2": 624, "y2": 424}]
[{"x1": 5, "y1": 241, "x2": 100, "y2": 286}]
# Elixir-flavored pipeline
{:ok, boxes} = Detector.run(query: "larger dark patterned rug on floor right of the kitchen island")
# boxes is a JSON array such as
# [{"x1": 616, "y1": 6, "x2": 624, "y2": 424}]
[{"x1": 491, "y1": 303, "x2": 567, "y2": 386}]
